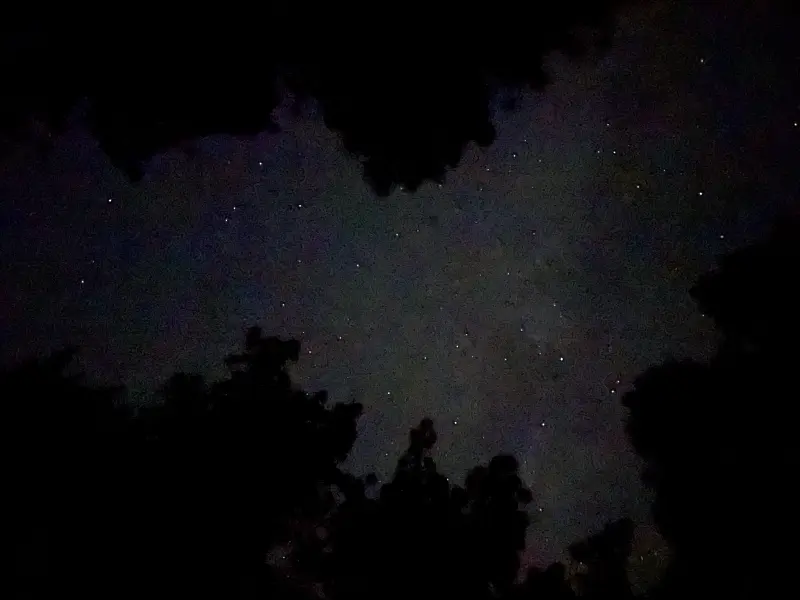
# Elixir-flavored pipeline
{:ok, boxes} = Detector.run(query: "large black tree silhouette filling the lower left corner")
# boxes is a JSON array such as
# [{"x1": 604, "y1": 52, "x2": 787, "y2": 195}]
[{"x1": 2, "y1": 328, "x2": 361, "y2": 598}]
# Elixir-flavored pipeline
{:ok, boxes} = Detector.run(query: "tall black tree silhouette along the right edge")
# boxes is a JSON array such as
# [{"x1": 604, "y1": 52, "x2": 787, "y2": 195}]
[{"x1": 623, "y1": 219, "x2": 800, "y2": 598}]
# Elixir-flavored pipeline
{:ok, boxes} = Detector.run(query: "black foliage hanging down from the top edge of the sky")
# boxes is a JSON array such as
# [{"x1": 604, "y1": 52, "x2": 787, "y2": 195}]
[{"x1": 0, "y1": 0, "x2": 633, "y2": 195}]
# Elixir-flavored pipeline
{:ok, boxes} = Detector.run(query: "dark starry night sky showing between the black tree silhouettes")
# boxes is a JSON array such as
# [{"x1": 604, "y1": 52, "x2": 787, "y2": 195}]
[{"x1": 0, "y1": 1, "x2": 800, "y2": 580}]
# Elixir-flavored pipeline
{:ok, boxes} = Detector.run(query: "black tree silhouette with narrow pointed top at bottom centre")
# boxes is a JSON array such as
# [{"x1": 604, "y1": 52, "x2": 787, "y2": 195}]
[{"x1": 300, "y1": 419, "x2": 531, "y2": 600}]
